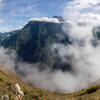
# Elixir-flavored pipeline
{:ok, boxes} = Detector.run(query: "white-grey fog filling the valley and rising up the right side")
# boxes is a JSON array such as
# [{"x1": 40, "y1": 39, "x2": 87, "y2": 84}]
[{"x1": 0, "y1": 0, "x2": 100, "y2": 93}]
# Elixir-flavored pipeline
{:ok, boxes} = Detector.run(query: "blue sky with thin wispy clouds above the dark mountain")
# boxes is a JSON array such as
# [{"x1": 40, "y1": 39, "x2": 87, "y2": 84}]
[{"x1": 0, "y1": 0, "x2": 69, "y2": 32}]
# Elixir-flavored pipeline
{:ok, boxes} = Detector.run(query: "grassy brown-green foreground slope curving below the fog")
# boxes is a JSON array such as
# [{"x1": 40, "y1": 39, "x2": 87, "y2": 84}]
[{"x1": 0, "y1": 64, "x2": 100, "y2": 100}]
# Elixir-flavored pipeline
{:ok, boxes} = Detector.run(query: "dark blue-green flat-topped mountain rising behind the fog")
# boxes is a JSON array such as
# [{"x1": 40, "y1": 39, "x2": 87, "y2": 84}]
[{"x1": 1, "y1": 16, "x2": 70, "y2": 71}]
